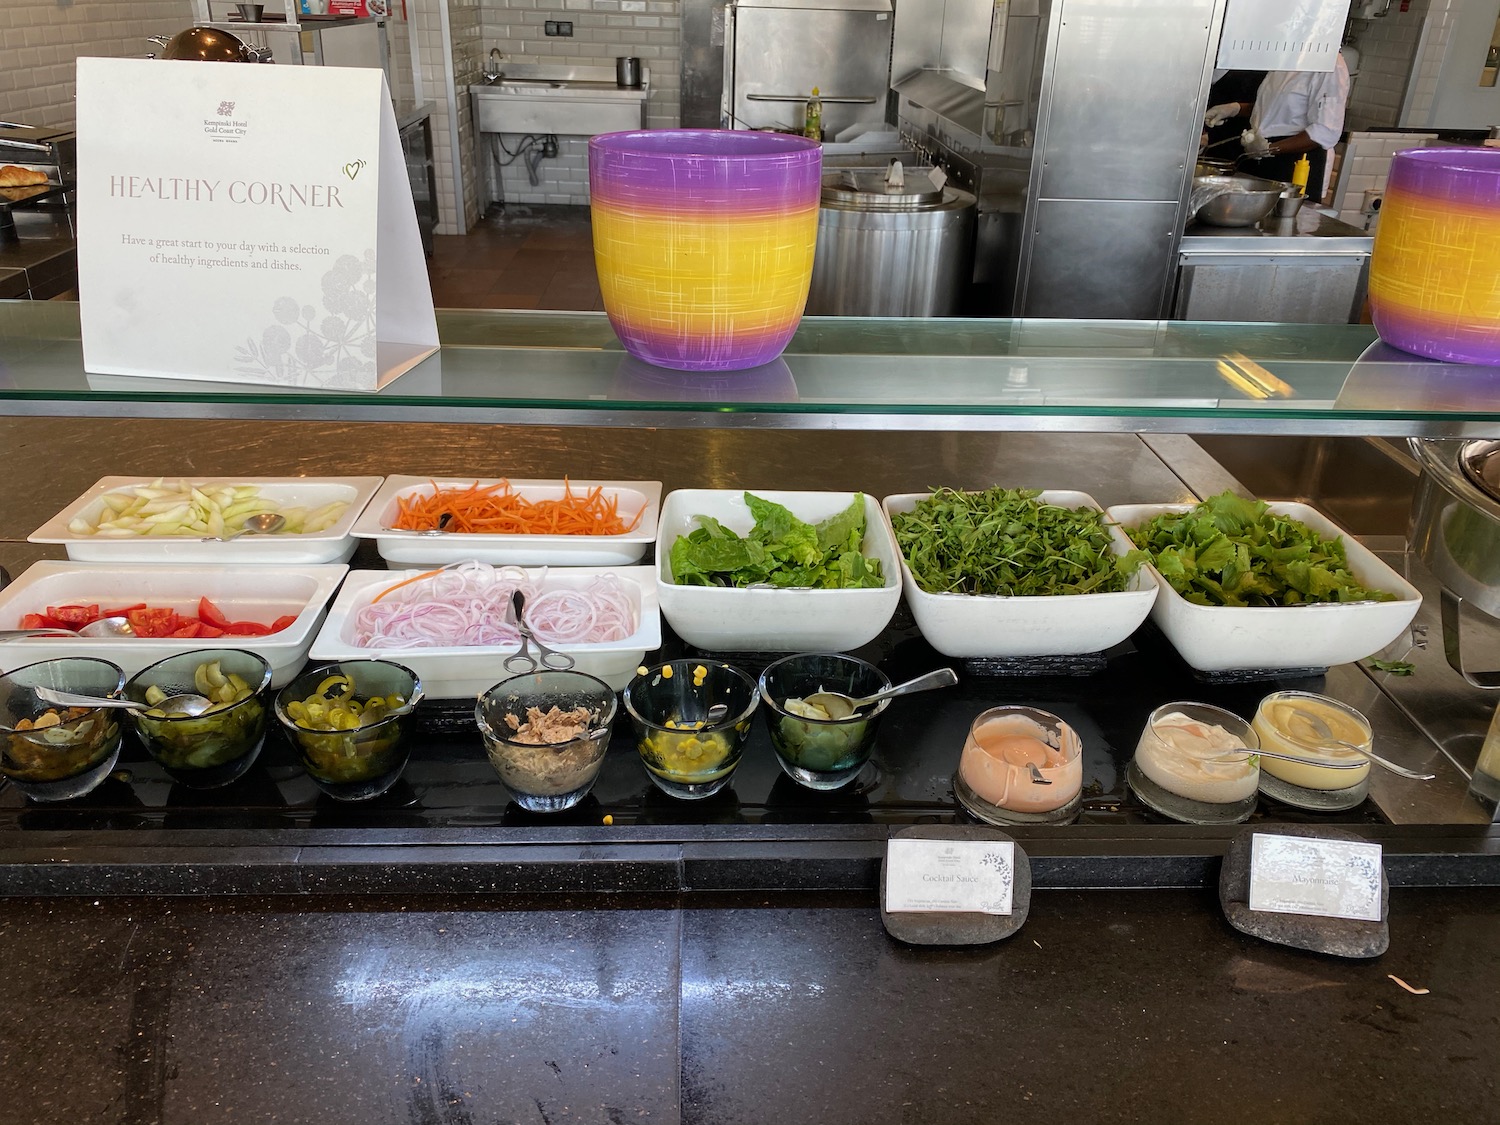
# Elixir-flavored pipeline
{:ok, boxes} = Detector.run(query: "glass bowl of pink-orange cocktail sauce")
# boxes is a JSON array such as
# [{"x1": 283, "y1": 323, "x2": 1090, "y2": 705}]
[{"x1": 953, "y1": 707, "x2": 1083, "y2": 825}]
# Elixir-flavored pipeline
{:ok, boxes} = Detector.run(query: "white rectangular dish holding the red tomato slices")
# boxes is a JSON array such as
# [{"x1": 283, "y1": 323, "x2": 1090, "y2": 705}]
[{"x1": 0, "y1": 563, "x2": 350, "y2": 687}]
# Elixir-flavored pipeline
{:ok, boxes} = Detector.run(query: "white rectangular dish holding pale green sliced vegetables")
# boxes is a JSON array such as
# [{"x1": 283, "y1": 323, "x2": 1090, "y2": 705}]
[{"x1": 27, "y1": 477, "x2": 383, "y2": 566}]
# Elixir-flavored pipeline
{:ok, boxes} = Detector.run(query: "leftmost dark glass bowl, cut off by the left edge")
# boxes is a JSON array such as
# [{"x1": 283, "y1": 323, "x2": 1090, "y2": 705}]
[{"x1": 0, "y1": 657, "x2": 125, "y2": 801}]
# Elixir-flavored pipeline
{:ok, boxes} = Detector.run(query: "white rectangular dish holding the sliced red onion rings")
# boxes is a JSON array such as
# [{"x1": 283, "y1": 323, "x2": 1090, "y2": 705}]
[{"x1": 311, "y1": 567, "x2": 662, "y2": 699}]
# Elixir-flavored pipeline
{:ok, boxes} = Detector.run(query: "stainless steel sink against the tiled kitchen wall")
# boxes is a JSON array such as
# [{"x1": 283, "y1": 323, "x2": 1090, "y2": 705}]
[{"x1": 470, "y1": 63, "x2": 650, "y2": 137}]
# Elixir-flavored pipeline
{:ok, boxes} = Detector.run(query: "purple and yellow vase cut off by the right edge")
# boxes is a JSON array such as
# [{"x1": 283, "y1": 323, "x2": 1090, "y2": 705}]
[{"x1": 1370, "y1": 149, "x2": 1500, "y2": 365}]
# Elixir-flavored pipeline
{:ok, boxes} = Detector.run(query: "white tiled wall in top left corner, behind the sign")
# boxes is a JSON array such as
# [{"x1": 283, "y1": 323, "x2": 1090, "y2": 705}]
[{"x1": 0, "y1": 0, "x2": 192, "y2": 125}]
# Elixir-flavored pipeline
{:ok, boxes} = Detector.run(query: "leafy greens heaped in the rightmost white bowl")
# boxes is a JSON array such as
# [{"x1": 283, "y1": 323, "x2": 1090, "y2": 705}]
[{"x1": 1127, "y1": 492, "x2": 1395, "y2": 606}]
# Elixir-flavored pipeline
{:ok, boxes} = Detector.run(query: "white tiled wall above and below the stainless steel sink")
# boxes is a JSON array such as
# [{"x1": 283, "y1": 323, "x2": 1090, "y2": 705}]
[{"x1": 480, "y1": 0, "x2": 683, "y2": 204}]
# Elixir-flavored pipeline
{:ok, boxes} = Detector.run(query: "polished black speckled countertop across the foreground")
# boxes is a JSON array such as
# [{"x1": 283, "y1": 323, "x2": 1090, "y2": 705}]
[{"x1": 0, "y1": 890, "x2": 1500, "y2": 1125}]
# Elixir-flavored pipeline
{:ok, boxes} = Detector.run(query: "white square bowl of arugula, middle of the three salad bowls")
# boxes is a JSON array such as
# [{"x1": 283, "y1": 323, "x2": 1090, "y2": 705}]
[{"x1": 881, "y1": 489, "x2": 1157, "y2": 659}]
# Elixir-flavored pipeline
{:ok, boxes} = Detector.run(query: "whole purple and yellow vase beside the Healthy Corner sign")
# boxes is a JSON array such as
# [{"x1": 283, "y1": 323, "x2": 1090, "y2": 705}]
[{"x1": 588, "y1": 129, "x2": 822, "y2": 371}]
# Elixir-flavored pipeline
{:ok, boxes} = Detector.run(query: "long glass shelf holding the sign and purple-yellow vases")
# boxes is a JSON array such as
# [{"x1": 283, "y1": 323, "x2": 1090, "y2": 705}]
[{"x1": 0, "y1": 302, "x2": 1500, "y2": 437}]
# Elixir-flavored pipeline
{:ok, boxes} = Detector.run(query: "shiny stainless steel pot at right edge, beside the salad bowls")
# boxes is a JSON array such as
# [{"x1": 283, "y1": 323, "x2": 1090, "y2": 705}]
[{"x1": 1407, "y1": 438, "x2": 1500, "y2": 687}]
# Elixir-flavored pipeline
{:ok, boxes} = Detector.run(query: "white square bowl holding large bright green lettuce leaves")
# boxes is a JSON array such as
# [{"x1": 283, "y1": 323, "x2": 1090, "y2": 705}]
[{"x1": 656, "y1": 489, "x2": 902, "y2": 653}]
